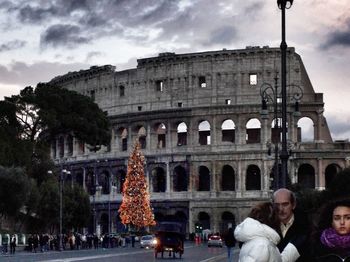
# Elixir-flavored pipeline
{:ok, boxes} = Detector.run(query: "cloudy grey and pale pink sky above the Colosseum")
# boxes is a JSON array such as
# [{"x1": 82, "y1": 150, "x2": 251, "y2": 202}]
[{"x1": 0, "y1": 0, "x2": 350, "y2": 139}]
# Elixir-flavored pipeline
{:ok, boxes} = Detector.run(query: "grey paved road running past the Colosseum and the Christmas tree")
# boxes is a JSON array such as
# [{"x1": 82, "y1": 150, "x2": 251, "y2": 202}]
[{"x1": 0, "y1": 242, "x2": 238, "y2": 262}]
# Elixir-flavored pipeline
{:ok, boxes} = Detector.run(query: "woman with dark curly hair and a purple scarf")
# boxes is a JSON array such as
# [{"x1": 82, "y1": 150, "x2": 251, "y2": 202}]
[{"x1": 312, "y1": 199, "x2": 350, "y2": 262}]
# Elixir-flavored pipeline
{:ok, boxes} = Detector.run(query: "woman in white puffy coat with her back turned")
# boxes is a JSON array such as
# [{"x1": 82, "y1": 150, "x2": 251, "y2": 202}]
[{"x1": 234, "y1": 202, "x2": 299, "y2": 262}]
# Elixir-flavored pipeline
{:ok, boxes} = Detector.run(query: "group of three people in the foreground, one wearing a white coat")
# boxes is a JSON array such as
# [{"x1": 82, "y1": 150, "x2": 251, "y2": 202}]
[{"x1": 229, "y1": 188, "x2": 350, "y2": 262}]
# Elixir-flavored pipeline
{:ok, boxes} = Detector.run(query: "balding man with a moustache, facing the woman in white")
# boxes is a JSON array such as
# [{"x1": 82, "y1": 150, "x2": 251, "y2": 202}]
[{"x1": 273, "y1": 188, "x2": 311, "y2": 262}]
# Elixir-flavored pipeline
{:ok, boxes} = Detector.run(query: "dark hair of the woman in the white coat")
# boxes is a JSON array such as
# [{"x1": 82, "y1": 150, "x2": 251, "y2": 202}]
[{"x1": 248, "y1": 202, "x2": 280, "y2": 232}]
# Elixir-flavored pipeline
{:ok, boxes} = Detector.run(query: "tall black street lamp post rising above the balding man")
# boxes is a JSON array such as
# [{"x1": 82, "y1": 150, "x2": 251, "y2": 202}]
[{"x1": 277, "y1": 0, "x2": 293, "y2": 188}]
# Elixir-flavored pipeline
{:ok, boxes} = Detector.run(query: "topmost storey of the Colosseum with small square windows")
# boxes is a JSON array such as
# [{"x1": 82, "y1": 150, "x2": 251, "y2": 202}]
[{"x1": 51, "y1": 46, "x2": 323, "y2": 115}]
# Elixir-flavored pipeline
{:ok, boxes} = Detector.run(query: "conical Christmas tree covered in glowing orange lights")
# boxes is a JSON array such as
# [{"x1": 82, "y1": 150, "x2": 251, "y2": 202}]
[{"x1": 118, "y1": 141, "x2": 156, "y2": 228}]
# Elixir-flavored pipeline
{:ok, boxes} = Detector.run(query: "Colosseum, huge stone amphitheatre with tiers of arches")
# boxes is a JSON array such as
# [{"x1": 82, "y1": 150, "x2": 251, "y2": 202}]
[{"x1": 51, "y1": 46, "x2": 350, "y2": 236}]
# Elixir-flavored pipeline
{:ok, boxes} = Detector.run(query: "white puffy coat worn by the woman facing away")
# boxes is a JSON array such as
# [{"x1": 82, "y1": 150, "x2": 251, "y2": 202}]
[{"x1": 234, "y1": 217, "x2": 299, "y2": 262}]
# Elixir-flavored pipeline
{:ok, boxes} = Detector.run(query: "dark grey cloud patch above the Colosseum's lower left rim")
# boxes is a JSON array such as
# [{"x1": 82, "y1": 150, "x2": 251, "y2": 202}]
[{"x1": 40, "y1": 24, "x2": 91, "y2": 47}]
